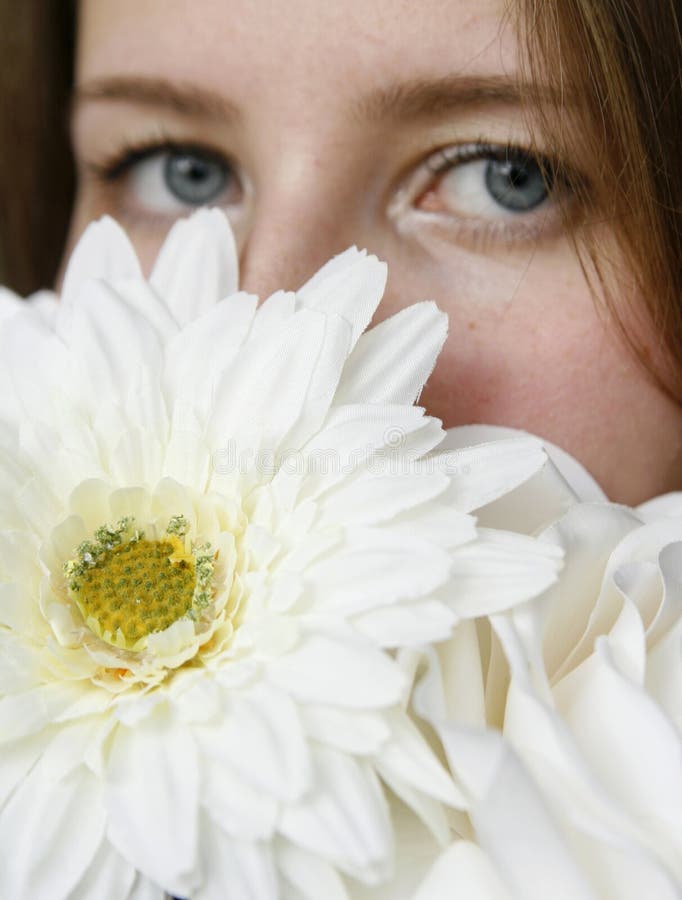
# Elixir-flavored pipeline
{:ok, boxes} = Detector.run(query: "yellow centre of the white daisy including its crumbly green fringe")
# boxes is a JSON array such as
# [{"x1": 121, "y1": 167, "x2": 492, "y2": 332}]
[{"x1": 64, "y1": 516, "x2": 213, "y2": 650}]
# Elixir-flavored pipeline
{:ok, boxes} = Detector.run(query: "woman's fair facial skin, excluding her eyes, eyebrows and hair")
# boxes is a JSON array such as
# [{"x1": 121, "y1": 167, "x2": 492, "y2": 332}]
[{"x1": 69, "y1": 0, "x2": 682, "y2": 503}]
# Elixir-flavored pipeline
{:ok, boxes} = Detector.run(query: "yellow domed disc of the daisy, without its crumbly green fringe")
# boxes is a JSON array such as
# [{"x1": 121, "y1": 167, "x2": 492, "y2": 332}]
[{"x1": 72, "y1": 536, "x2": 195, "y2": 646}]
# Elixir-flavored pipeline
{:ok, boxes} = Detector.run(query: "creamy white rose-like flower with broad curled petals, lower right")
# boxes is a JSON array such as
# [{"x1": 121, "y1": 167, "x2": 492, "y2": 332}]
[{"x1": 415, "y1": 454, "x2": 682, "y2": 900}]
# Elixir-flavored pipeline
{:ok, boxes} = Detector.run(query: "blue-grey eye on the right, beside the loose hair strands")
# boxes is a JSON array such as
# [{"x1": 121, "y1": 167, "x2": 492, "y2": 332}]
[{"x1": 416, "y1": 144, "x2": 555, "y2": 221}]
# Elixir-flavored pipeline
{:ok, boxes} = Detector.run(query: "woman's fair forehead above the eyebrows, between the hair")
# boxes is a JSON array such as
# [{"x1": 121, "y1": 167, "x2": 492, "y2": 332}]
[{"x1": 77, "y1": 0, "x2": 516, "y2": 98}]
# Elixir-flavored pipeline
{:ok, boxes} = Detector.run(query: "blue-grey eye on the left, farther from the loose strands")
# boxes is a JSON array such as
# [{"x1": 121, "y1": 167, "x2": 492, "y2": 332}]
[{"x1": 91, "y1": 143, "x2": 243, "y2": 215}]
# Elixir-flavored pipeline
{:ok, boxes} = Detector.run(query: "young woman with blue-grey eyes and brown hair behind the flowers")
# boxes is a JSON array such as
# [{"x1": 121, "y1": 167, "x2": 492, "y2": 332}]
[{"x1": 0, "y1": 0, "x2": 682, "y2": 503}]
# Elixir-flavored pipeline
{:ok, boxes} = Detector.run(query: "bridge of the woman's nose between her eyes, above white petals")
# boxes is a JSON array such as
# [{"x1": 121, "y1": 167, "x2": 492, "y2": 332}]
[{"x1": 240, "y1": 146, "x2": 361, "y2": 298}]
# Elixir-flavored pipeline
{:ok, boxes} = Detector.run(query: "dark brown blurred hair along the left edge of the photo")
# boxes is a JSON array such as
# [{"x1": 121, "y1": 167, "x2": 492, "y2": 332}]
[{"x1": 0, "y1": 0, "x2": 75, "y2": 295}]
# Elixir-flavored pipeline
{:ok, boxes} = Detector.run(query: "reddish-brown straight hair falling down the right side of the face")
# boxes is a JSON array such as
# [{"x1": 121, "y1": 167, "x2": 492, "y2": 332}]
[{"x1": 510, "y1": 0, "x2": 682, "y2": 399}]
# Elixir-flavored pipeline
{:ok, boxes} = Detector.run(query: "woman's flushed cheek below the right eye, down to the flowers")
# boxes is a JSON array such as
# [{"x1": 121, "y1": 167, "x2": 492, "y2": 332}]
[{"x1": 383, "y1": 239, "x2": 682, "y2": 503}]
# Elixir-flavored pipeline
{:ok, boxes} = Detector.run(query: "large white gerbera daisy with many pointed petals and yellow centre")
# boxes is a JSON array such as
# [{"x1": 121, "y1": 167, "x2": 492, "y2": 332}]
[{"x1": 0, "y1": 212, "x2": 560, "y2": 900}]
